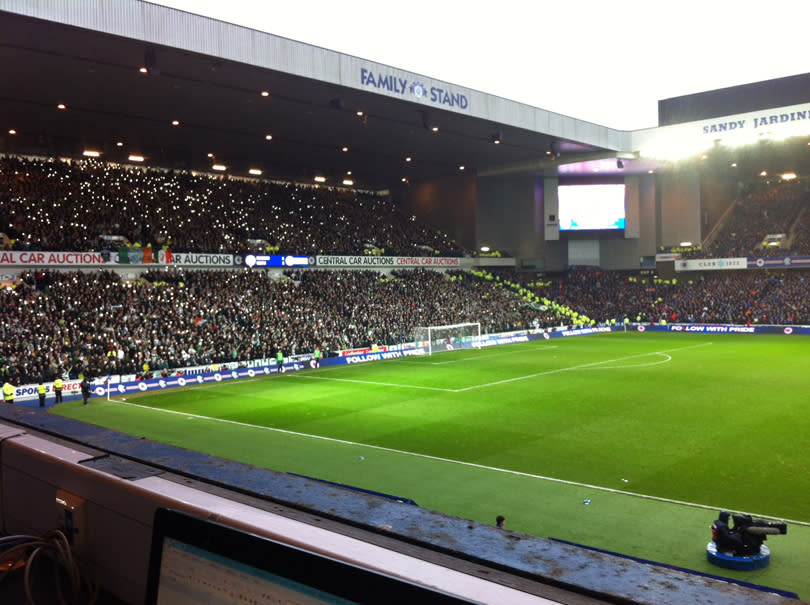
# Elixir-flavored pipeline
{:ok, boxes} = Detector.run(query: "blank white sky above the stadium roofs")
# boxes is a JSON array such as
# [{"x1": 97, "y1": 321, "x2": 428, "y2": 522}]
[{"x1": 150, "y1": 0, "x2": 810, "y2": 130}]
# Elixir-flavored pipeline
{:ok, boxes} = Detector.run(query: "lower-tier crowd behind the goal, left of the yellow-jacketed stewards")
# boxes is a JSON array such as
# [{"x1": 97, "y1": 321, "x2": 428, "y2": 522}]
[{"x1": 0, "y1": 270, "x2": 539, "y2": 382}]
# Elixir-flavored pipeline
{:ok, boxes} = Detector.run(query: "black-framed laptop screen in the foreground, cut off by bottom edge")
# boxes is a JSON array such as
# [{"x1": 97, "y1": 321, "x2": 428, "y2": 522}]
[{"x1": 146, "y1": 508, "x2": 470, "y2": 605}]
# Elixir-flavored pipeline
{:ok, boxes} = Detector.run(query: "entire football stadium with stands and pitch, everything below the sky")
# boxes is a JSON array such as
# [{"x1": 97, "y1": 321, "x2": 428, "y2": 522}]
[{"x1": 0, "y1": 0, "x2": 810, "y2": 605}]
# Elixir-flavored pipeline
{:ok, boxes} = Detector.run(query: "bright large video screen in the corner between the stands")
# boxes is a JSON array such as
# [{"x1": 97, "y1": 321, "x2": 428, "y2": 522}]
[{"x1": 557, "y1": 184, "x2": 625, "y2": 231}]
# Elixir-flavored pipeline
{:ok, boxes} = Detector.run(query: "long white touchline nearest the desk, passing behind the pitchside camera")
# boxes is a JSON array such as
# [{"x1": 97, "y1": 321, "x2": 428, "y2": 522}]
[{"x1": 99, "y1": 394, "x2": 810, "y2": 527}]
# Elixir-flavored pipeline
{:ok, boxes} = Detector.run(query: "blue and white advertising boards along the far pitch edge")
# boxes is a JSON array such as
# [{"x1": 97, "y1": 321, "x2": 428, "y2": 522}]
[{"x1": 14, "y1": 324, "x2": 810, "y2": 404}]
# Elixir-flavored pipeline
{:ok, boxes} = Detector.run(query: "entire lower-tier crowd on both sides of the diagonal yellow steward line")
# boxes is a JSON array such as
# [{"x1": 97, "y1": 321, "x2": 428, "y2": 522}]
[{"x1": 0, "y1": 268, "x2": 810, "y2": 384}]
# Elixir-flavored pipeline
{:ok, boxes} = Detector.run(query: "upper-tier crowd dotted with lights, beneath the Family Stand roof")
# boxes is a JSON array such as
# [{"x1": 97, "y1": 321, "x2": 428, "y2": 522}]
[{"x1": 0, "y1": 157, "x2": 468, "y2": 256}]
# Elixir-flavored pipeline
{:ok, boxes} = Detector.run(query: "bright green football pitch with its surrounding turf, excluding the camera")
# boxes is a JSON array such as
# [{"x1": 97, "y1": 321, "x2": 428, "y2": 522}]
[{"x1": 53, "y1": 332, "x2": 810, "y2": 599}]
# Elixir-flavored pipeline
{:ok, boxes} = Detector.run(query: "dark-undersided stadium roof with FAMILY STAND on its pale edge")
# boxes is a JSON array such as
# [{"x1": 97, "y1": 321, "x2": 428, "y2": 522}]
[{"x1": 0, "y1": 0, "x2": 810, "y2": 190}]
